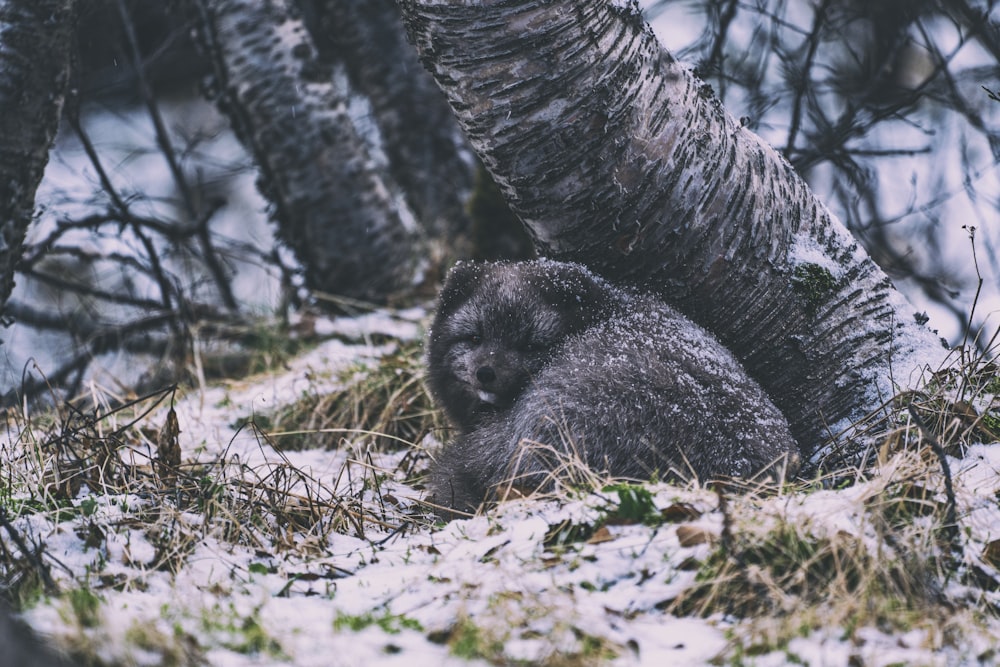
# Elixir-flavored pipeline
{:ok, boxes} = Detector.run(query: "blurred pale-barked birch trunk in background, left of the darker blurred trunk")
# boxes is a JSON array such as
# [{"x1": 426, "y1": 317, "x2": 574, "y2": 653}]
[{"x1": 187, "y1": 0, "x2": 419, "y2": 302}]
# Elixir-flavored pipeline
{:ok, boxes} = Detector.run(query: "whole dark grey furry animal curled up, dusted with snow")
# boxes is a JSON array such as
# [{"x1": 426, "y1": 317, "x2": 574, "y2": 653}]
[{"x1": 427, "y1": 260, "x2": 799, "y2": 512}]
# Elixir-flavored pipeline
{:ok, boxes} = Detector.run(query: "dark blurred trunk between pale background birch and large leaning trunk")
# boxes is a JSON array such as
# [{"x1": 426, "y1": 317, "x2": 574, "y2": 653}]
[{"x1": 300, "y1": 0, "x2": 475, "y2": 241}]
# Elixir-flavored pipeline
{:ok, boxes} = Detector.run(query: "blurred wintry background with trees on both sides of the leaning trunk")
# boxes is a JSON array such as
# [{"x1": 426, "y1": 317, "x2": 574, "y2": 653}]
[{"x1": 0, "y1": 0, "x2": 1000, "y2": 404}]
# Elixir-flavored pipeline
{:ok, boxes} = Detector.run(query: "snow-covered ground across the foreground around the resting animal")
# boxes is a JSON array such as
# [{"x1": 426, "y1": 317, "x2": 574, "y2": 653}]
[{"x1": 0, "y1": 310, "x2": 1000, "y2": 667}]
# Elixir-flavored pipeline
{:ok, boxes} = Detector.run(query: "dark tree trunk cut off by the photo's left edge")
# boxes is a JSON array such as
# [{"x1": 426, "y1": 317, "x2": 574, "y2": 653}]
[{"x1": 0, "y1": 0, "x2": 76, "y2": 314}]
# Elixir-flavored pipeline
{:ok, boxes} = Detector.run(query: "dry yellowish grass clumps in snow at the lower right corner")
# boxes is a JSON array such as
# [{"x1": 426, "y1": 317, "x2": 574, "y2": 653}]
[{"x1": 665, "y1": 340, "x2": 1000, "y2": 662}]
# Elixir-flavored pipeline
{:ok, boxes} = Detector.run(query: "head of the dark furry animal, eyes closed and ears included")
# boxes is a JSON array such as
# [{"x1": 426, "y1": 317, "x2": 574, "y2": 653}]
[{"x1": 428, "y1": 262, "x2": 600, "y2": 429}]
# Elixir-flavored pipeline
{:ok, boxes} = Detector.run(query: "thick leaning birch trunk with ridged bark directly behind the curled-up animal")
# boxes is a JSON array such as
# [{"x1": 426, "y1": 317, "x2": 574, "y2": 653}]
[{"x1": 400, "y1": 0, "x2": 944, "y2": 455}]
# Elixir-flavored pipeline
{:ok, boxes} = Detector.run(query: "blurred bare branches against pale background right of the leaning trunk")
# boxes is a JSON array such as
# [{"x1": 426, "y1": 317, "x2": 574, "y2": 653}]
[{"x1": 647, "y1": 0, "x2": 1000, "y2": 345}]
